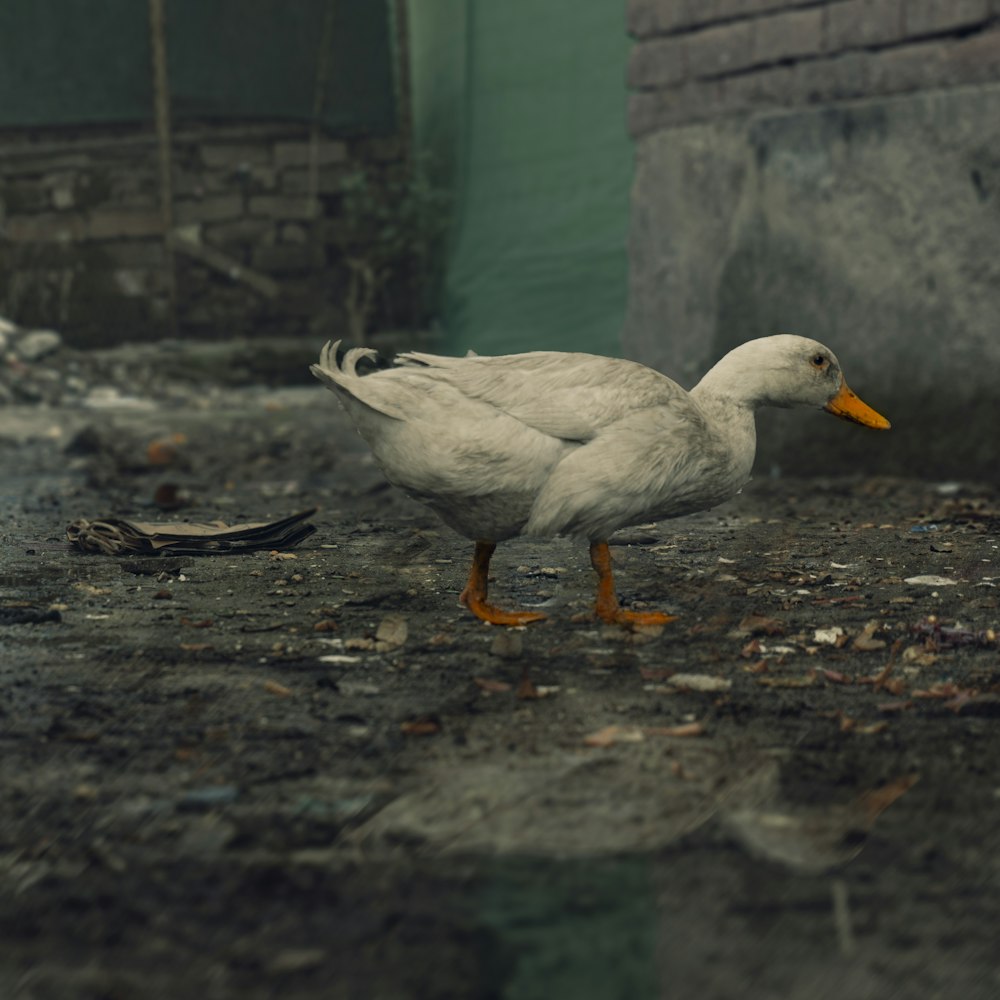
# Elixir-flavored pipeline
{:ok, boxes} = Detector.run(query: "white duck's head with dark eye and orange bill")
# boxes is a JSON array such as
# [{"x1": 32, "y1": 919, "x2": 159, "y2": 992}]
[{"x1": 699, "y1": 334, "x2": 890, "y2": 430}]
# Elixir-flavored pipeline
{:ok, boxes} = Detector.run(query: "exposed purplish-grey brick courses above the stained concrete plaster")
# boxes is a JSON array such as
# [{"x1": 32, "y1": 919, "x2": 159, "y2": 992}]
[{"x1": 629, "y1": 0, "x2": 1000, "y2": 137}]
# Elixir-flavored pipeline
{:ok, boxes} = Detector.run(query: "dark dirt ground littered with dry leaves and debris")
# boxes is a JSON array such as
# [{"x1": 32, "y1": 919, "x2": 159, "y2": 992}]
[{"x1": 0, "y1": 346, "x2": 1000, "y2": 1000}]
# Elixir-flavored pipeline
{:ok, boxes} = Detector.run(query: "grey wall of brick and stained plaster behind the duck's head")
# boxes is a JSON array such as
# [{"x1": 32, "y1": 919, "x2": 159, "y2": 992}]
[{"x1": 624, "y1": 0, "x2": 1000, "y2": 480}]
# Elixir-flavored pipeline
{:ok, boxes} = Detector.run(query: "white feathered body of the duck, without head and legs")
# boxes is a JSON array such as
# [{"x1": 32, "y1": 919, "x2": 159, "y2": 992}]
[{"x1": 308, "y1": 351, "x2": 756, "y2": 541}]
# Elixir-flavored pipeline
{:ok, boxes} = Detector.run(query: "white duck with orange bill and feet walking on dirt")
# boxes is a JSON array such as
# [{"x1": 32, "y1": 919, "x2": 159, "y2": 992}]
[{"x1": 311, "y1": 335, "x2": 889, "y2": 625}]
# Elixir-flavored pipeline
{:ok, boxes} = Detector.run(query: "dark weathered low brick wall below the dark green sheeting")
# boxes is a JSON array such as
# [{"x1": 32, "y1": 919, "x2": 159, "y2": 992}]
[{"x1": 0, "y1": 124, "x2": 401, "y2": 346}]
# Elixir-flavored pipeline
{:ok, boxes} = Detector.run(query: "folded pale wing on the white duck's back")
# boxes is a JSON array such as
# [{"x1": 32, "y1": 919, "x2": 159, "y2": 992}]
[{"x1": 397, "y1": 351, "x2": 687, "y2": 442}]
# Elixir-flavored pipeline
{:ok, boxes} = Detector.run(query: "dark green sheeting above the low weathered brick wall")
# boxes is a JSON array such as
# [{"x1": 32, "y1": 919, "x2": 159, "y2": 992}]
[{"x1": 0, "y1": 0, "x2": 396, "y2": 135}]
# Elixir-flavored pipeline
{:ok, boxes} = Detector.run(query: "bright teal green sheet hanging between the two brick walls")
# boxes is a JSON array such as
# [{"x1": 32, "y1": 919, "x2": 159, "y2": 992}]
[{"x1": 409, "y1": 0, "x2": 632, "y2": 354}]
